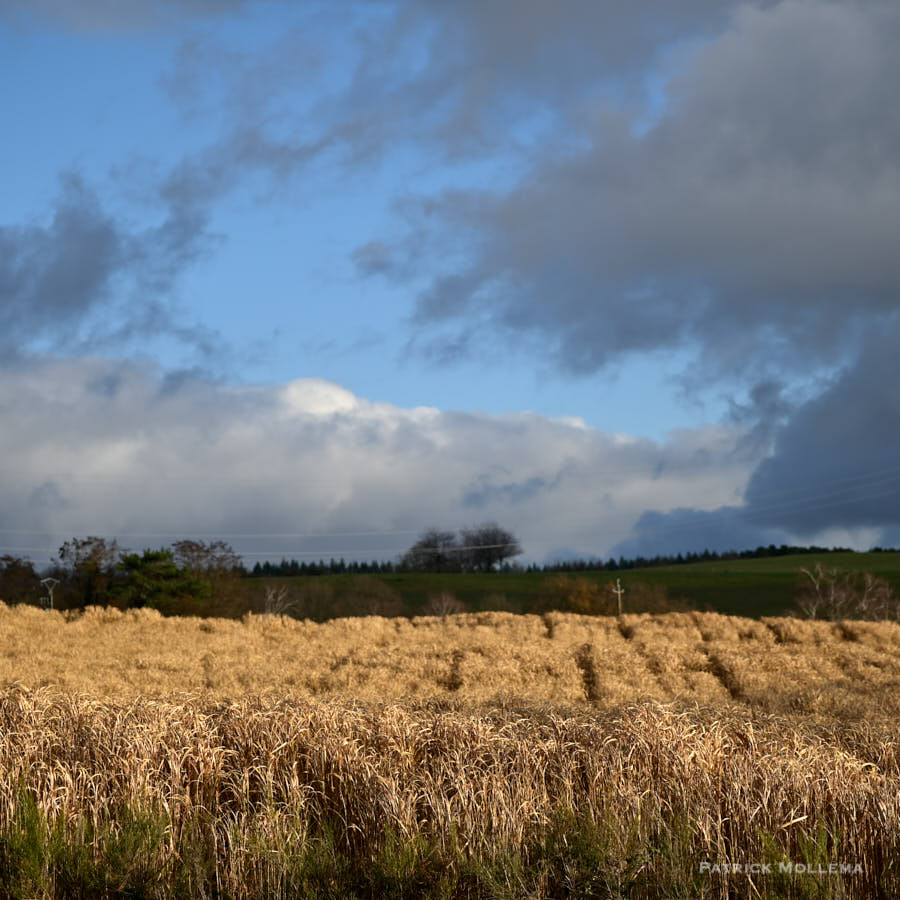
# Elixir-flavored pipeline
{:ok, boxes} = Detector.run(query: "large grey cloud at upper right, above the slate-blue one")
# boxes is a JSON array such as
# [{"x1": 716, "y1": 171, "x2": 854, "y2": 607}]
[{"x1": 361, "y1": 0, "x2": 900, "y2": 381}]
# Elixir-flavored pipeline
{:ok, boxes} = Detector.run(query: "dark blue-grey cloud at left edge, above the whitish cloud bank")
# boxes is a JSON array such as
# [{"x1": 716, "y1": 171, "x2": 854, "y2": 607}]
[{"x1": 0, "y1": 173, "x2": 215, "y2": 360}]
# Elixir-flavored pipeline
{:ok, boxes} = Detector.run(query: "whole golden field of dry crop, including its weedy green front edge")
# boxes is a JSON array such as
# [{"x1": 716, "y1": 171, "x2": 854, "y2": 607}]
[{"x1": 0, "y1": 605, "x2": 900, "y2": 898}]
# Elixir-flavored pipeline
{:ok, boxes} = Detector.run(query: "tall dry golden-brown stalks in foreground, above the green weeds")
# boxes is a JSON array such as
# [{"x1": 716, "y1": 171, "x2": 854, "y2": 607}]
[{"x1": 0, "y1": 689, "x2": 900, "y2": 896}]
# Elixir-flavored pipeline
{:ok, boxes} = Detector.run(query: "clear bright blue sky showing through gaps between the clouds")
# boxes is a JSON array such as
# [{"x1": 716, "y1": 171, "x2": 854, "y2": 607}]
[{"x1": 0, "y1": 5, "x2": 722, "y2": 438}]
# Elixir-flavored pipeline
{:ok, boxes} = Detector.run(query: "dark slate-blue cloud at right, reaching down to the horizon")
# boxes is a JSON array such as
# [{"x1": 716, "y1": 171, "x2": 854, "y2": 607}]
[{"x1": 615, "y1": 322, "x2": 900, "y2": 556}]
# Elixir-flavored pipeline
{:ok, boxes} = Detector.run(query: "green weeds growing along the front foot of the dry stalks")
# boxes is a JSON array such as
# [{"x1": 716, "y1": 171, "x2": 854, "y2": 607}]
[{"x1": 0, "y1": 794, "x2": 872, "y2": 900}]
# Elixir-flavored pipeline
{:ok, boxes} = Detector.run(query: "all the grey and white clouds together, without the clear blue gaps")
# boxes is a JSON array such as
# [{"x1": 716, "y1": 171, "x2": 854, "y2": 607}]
[{"x1": 0, "y1": 0, "x2": 900, "y2": 558}]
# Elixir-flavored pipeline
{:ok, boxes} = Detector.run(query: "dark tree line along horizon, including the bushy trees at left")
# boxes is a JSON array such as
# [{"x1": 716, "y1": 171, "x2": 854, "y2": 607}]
[{"x1": 0, "y1": 522, "x2": 896, "y2": 614}]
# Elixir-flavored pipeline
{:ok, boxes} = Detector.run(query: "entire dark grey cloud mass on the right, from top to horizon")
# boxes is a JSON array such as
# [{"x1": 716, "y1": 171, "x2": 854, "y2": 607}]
[{"x1": 356, "y1": 0, "x2": 900, "y2": 552}]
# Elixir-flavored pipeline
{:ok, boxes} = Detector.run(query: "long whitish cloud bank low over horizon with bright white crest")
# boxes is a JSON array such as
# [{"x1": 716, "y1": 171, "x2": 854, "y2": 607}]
[{"x1": 0, "y1": 358, "x2": 754, "y2": 562}]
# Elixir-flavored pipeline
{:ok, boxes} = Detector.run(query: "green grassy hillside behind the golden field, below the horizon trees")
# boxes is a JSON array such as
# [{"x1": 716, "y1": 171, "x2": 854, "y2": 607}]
[{"x1": 243, "y1": 553, "x2": 900, "y2": 617}]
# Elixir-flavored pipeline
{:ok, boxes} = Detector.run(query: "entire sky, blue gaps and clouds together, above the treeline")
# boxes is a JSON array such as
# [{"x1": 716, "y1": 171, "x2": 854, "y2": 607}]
[{"x1": 0, "y1": 0, "x2": 900, "y2": 564}]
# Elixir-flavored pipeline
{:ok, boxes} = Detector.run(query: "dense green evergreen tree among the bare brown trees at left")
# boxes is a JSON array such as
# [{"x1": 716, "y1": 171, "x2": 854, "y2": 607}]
[{"x1": 113, "y1": 548, "x2": 212, "y2": 612}]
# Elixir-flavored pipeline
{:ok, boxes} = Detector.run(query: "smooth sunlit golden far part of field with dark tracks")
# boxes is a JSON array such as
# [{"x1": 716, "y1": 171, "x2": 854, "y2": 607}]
[{"x1": 0, "y1": 605, "x2": 900, "y2": 720}]
